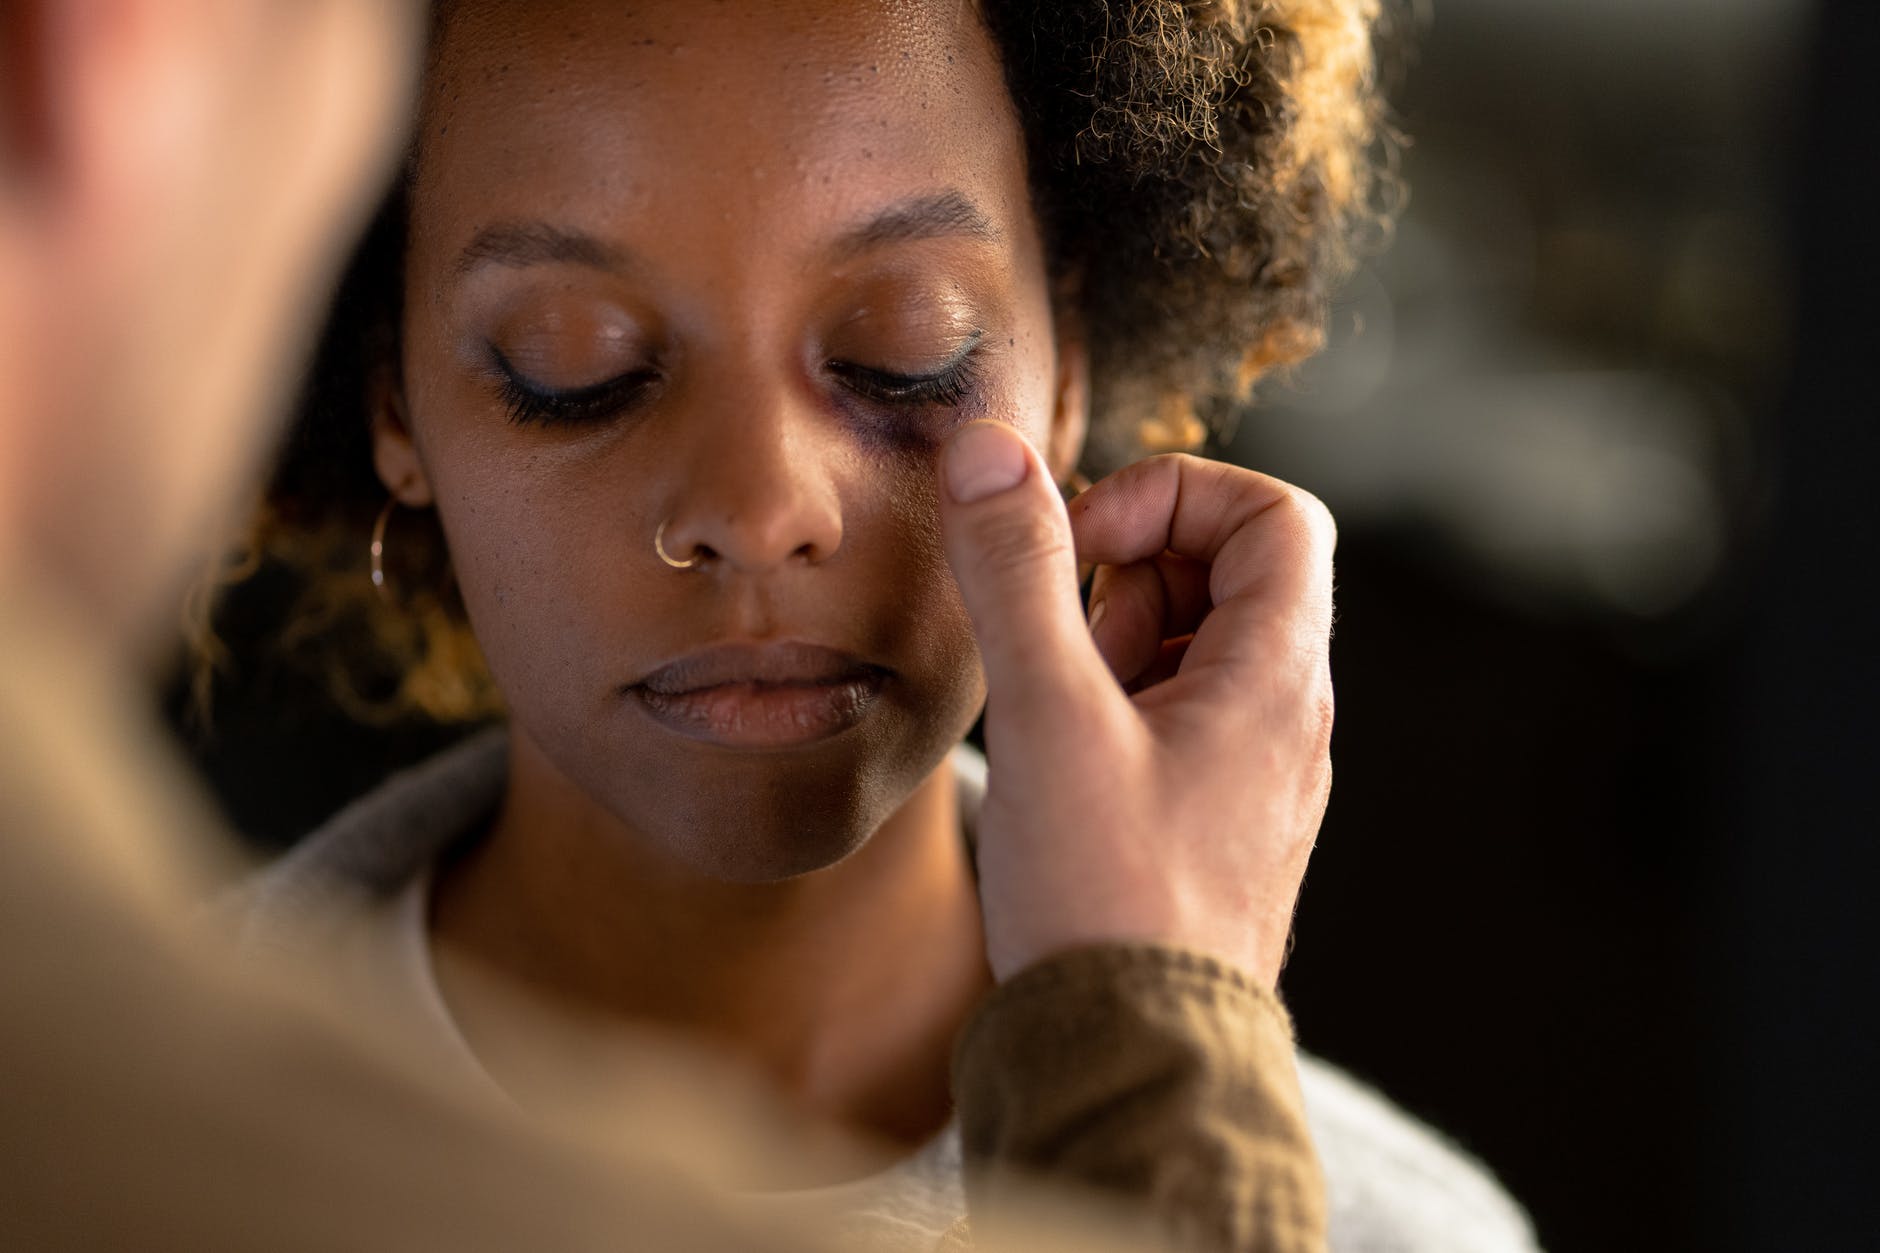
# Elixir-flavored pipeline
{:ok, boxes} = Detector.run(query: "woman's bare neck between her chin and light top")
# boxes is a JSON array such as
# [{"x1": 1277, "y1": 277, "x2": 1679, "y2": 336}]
[{"x1": 432, "y1": 732, "x2": 991, "y2": 1142}]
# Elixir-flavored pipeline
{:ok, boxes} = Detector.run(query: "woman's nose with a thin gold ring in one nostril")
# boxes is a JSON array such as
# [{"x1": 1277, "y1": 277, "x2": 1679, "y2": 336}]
[{"x1": 658, "y1": 370, "x2": 842, "y2": 574}]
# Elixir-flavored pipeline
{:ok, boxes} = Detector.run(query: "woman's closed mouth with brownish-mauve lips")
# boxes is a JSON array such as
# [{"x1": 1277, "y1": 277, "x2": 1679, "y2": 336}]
[{"x1": 626, "y1": 642, "x2": 891, "y2": 749}]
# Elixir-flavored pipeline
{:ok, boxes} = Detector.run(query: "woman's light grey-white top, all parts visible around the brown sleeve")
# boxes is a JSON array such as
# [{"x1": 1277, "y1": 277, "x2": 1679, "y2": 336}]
[{"x1": 229, "y1": 728, "x2": 1538, "y2": 1253}]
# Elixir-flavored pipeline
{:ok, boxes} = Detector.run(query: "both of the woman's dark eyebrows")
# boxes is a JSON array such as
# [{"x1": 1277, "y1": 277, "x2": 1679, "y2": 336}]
[{"x1": 457, "y1": 190, "x2": 1002, "y2": 277}]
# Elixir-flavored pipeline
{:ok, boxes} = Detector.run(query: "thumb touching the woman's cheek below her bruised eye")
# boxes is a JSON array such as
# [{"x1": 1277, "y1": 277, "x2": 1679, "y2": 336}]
[{"x1": 940, "y1": 421, "x2": 1113, "y2": 728}]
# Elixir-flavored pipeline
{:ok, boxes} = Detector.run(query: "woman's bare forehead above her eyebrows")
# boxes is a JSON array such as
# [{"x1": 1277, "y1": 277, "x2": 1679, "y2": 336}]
[{"x1": 417, "y1": 0, "x2": 1028, "y2": 269}]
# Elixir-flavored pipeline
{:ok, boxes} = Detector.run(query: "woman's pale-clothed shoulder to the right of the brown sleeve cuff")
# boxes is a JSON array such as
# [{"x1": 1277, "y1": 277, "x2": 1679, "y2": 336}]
[{"x1": 1299, "y1": 1054, "x2": 1538, "y2": 1253}]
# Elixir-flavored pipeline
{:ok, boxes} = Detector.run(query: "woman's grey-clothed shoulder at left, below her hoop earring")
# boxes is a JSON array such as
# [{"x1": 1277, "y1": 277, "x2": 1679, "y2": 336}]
[{"x1": 212, "y1": 726, "x2": 508, "y2": 950}]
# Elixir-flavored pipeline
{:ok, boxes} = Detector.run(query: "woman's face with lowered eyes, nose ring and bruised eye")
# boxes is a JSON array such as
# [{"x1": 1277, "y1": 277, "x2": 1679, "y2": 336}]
[{"x1": 376, "y1": 0, "x2": 1083, "y2": 880}]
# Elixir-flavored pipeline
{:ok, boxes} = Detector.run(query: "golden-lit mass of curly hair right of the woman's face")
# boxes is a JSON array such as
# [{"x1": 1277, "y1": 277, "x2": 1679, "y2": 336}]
[{"x1": 983, "y1": 0, "x2": 1391, "y2": 468}]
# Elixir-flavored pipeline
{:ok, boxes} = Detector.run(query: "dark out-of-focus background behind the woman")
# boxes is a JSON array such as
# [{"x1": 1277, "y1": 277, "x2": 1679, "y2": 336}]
[{"x1": 173, "y1": 0, "x2": 1880, "y2": 1251}]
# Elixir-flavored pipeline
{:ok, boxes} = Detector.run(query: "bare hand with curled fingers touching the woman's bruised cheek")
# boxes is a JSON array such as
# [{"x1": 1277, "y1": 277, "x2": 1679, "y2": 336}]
[{"x1": 940, "y1": 421, "x2": 1335, "y2": 988}]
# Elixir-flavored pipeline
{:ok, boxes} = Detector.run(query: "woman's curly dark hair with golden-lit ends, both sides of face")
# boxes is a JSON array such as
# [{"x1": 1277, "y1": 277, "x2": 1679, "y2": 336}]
[{"x1": 213, "y1": 0, "x2": 1395, "y2": 721}]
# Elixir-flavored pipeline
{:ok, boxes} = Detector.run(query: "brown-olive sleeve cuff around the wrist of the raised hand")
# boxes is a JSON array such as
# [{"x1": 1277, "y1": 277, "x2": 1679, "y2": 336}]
[{"x1": 953, "y1": 944, "x2": 1325, "y2": 1253}]
